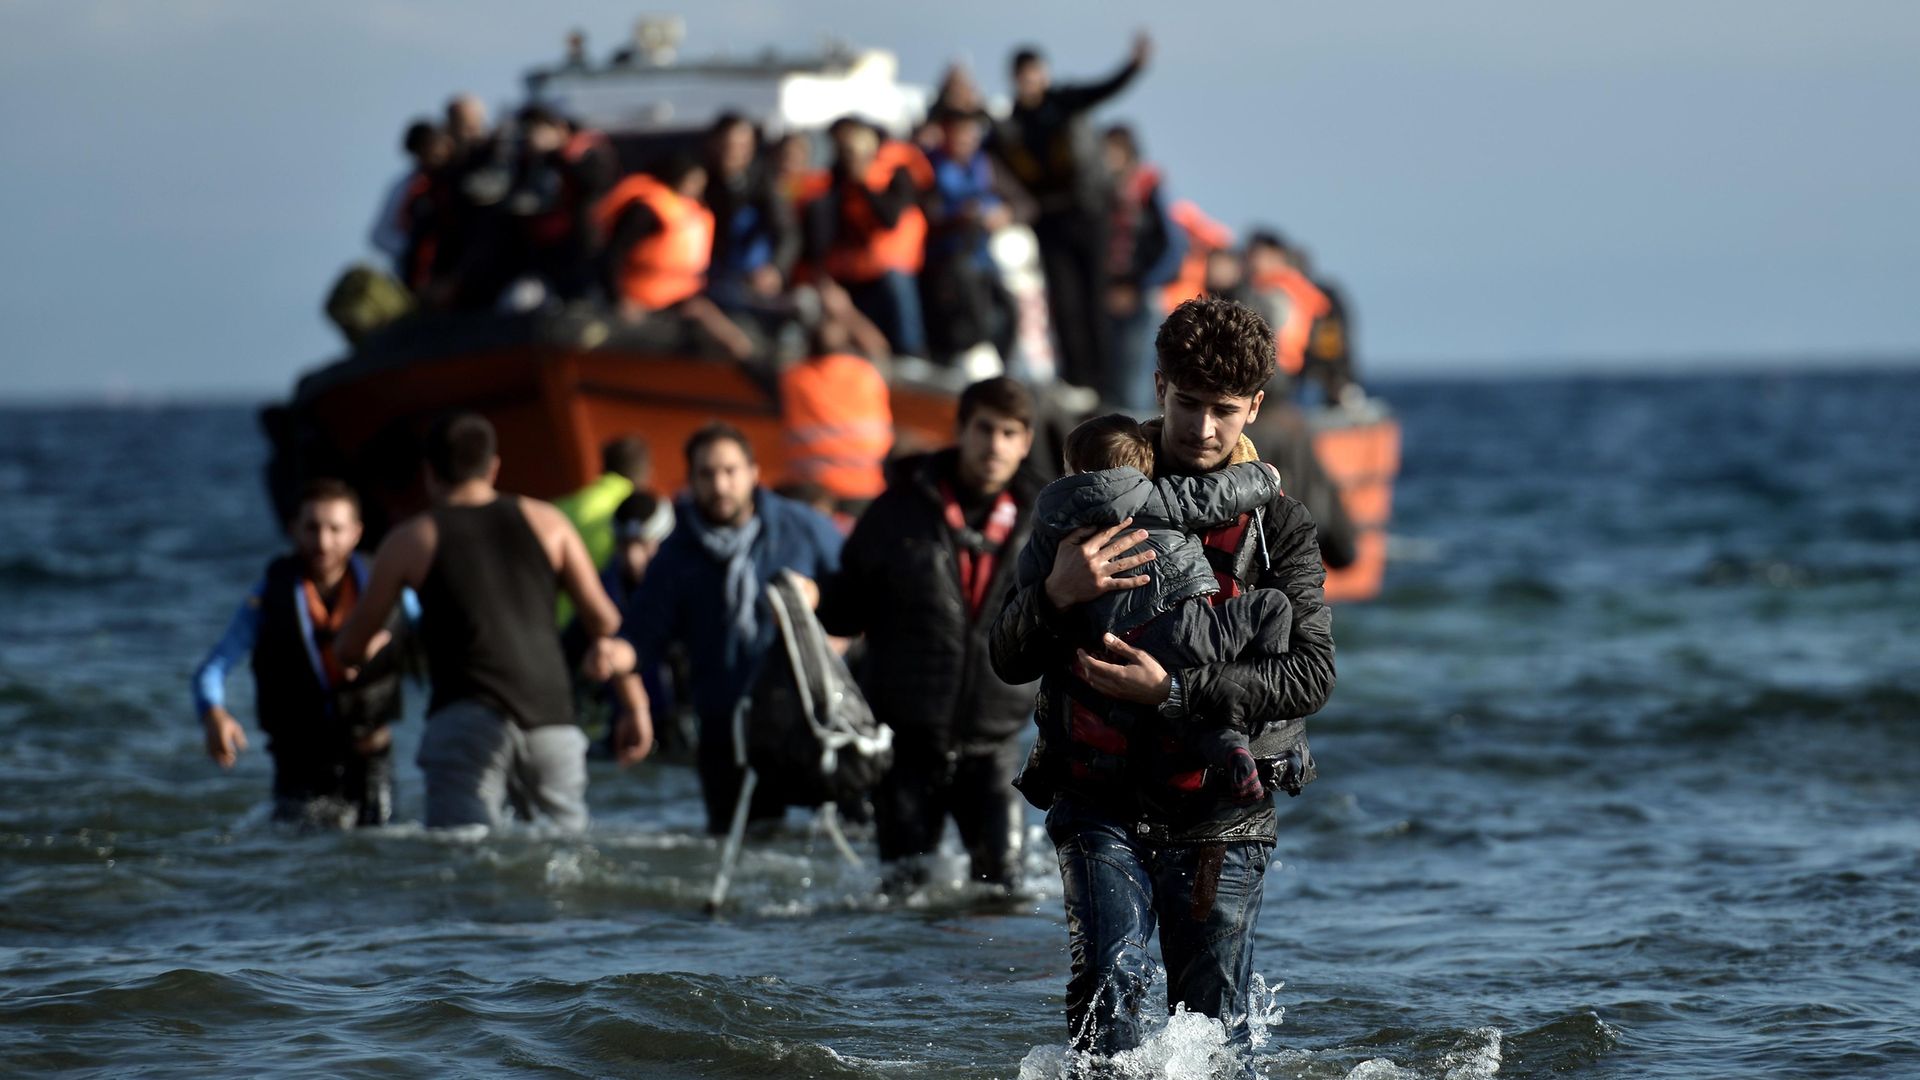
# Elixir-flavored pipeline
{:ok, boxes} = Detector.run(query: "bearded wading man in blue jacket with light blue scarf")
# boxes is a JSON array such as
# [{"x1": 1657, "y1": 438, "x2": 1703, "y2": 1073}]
[{"x1": 620, "y1": 421, "x2": 841, "y2": 834}]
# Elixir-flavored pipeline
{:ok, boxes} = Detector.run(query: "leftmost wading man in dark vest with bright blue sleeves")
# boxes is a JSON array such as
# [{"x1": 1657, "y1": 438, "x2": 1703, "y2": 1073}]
[{"x1": 194, "y1": 480, "x2": 419, "y2": 828}]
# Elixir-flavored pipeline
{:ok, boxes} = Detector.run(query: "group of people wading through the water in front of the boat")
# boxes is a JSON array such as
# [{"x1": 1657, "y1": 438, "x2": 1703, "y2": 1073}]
[{"x1": 194, "y1": 290, "x2": 1332, "y2": 1055}]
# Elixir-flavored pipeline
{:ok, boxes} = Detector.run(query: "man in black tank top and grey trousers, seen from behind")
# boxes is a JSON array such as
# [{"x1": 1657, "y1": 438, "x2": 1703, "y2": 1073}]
[{"x1": 336, "y1": 413, "x2": 653, "y2": 830}]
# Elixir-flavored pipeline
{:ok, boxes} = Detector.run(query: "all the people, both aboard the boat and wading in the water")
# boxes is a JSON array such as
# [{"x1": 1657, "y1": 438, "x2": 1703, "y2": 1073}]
[{"x1": 206, "y1": 37, "x2": 1352, "y2": 1061}]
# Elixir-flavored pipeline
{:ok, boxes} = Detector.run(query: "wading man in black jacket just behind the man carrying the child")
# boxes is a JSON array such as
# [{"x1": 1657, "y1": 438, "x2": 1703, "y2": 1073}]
[{"x1": 820, "y1": 377, "x2": 1037, "y2": 892}]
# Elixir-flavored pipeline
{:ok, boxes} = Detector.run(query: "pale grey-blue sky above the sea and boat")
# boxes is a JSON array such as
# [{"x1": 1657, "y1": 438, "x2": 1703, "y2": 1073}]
[{"x1": 0, "y1": 0, "x2": 1920, "y2": 396}]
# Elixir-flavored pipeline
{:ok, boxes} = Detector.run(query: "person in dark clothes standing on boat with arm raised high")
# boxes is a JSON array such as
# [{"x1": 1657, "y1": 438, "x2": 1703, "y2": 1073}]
[{"x1": 993, "y1": 35, "x2": 1152, "y2": 395}]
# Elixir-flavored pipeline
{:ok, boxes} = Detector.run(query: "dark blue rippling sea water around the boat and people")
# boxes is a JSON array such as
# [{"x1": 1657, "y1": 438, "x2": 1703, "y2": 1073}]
[{"x1": 0, "y1": 365, "x2": 1920, "y2": 1078}]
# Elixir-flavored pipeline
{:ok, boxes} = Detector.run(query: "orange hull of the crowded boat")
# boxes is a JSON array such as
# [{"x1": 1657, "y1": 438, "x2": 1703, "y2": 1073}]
[{"x1": 271, "y1": 317, "x2": 1400, "y2": 601}]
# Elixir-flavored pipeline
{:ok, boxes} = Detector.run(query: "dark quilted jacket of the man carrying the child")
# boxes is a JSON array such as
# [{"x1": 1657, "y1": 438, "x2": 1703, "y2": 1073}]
[{"x1": 991, "y1": 438, "x2": 1334, "y2": 844}]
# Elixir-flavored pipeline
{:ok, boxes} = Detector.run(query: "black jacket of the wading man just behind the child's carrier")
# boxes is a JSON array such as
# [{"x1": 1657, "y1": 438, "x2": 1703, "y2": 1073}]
[{"x1": 820, "y1": 450, "x2": 1037, "y2": 753}]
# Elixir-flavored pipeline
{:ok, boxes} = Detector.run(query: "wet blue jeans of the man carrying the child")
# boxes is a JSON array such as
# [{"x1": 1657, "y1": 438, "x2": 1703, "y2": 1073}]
[{"x1": 1046, "y1": 796, "x2": 1273, "y2": 1057}]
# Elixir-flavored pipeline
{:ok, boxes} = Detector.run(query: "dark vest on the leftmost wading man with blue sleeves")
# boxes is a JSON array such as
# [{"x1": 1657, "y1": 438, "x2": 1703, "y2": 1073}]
[{"x1": 252, "y1": 555, "x2": 403, "y2": 749}]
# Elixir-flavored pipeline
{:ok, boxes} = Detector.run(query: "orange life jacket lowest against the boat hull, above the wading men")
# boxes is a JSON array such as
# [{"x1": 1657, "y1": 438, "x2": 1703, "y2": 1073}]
[{"x1": 780, "y1": 354, "x2": 893, "y2": 500}]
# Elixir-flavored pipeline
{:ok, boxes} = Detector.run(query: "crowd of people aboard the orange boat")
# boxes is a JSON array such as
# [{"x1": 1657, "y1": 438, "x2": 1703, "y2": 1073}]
[{"x1": 357, "y1": 35, "x2": 1352, "y2": 411}]
